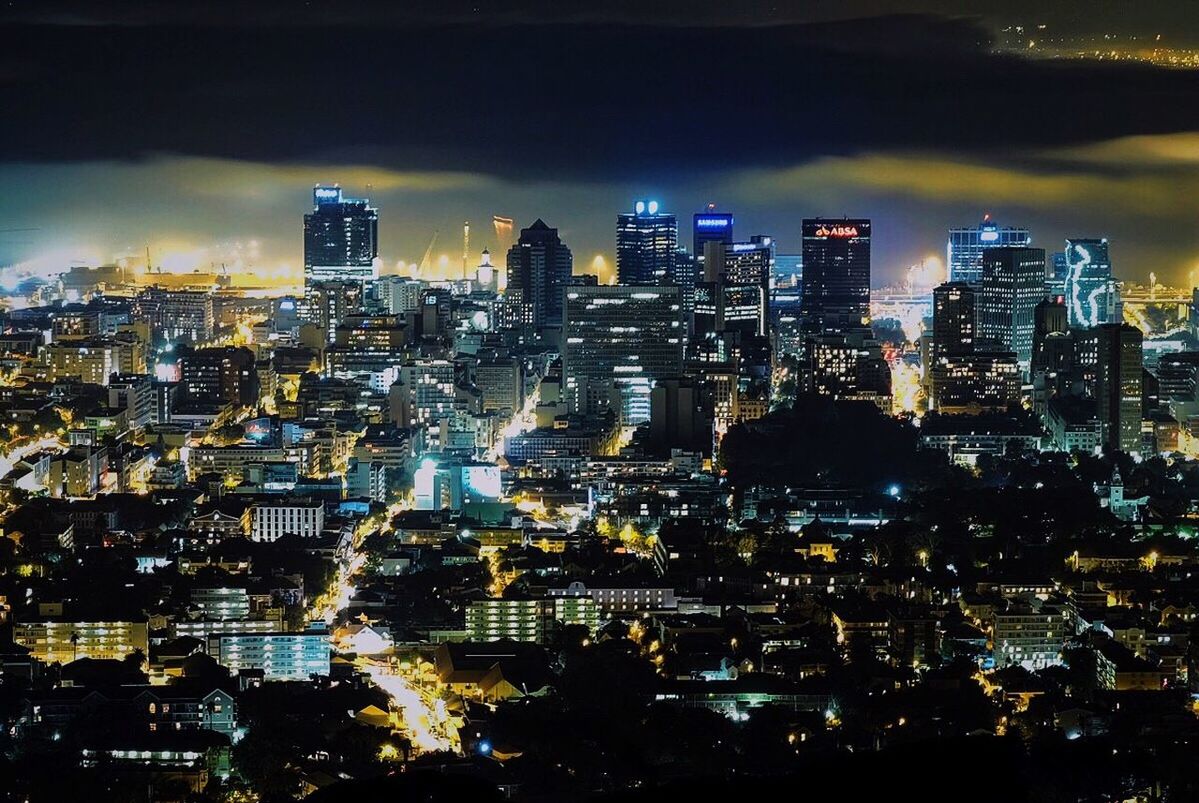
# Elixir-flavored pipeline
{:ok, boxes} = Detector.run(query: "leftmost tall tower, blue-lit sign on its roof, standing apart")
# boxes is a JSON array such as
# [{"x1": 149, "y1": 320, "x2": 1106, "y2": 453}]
[{"x1": 303, "y1": 186, "x2": 379, "y2": 288}]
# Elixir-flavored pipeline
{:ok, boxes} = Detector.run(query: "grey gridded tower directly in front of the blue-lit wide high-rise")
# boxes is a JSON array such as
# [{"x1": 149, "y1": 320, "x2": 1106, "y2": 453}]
[{"x1": 977, "y1": 248, "x2": 1046, "y2": 372}]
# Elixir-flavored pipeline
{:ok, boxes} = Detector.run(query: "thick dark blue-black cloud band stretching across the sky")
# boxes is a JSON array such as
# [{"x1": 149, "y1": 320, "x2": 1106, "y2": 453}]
[{"x1": 0, "y1": 16, "x2": 1199, "y2": 180}]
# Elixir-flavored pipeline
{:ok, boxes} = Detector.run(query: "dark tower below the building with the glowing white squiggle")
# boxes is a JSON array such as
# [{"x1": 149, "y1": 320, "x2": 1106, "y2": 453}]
[{"x1": 1074, "y1": 324, "x2": 1143, "y2": 452}]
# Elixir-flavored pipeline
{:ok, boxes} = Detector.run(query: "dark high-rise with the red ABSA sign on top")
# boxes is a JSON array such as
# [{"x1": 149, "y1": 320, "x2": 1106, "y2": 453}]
[{"x1": 800, "y1": 218, "x2": 870, "y2": 334}]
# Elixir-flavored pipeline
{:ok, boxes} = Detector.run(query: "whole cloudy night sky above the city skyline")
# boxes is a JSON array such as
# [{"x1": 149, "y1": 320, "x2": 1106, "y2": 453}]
[{"x1": 0, "y1": 0, "x2": 1199, "y2": 284}]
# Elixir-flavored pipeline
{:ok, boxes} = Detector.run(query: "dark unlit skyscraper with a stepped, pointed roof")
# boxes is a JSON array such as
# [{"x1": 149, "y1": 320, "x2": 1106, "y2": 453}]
[{"x1": 507, "y1": 218, "x2": 574, "y2": 327}]
